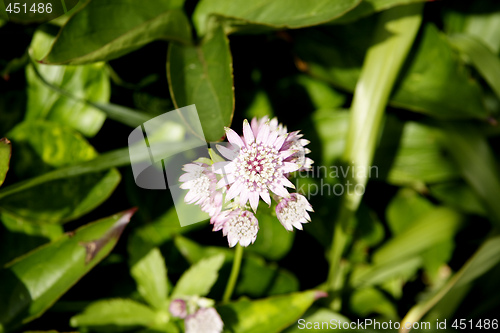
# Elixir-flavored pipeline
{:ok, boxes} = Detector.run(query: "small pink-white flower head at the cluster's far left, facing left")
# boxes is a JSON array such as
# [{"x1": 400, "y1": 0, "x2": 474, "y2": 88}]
[{"x1": 179, "y1": 162, "x2": 222, "y2": 217}]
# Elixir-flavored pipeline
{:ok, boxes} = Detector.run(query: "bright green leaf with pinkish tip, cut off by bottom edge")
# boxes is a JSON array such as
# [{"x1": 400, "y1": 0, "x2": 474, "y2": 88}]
[{"x1": 217, "y1": 290, "x2": 324, "y2": 333}]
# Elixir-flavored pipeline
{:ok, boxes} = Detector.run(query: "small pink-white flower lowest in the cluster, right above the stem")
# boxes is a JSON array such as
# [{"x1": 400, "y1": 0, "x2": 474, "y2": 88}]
[{"x1": 210, "y1": 208, "x2": 259, "y2": 247}]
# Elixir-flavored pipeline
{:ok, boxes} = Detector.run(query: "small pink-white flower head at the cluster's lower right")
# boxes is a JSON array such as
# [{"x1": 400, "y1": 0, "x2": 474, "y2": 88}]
[{"x1": 276, "y1": 193, "x2": 313, "y2": 231}]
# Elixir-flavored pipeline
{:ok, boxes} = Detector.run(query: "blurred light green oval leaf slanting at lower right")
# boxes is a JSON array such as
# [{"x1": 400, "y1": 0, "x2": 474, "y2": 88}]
[{"x1": 373, "y1": 208, "x2": 462, "y2": 264}]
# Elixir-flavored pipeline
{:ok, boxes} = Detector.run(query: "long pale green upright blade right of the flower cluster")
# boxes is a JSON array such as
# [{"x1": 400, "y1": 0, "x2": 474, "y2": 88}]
[{"x1": 328, "y1": 4, "x2": 422, "y2": 310}]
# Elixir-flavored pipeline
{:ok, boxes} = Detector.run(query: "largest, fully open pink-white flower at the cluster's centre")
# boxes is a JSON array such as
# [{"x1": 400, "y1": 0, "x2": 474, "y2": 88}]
[{"x1": 214, "y1": 120, "x2": 300, "y2": 211}]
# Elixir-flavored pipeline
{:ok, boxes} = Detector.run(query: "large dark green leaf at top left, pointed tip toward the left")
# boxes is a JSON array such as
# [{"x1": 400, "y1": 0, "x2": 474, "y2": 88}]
[{"x1": 42, "y1": 0, "x2": 191, "y2": 64}]
